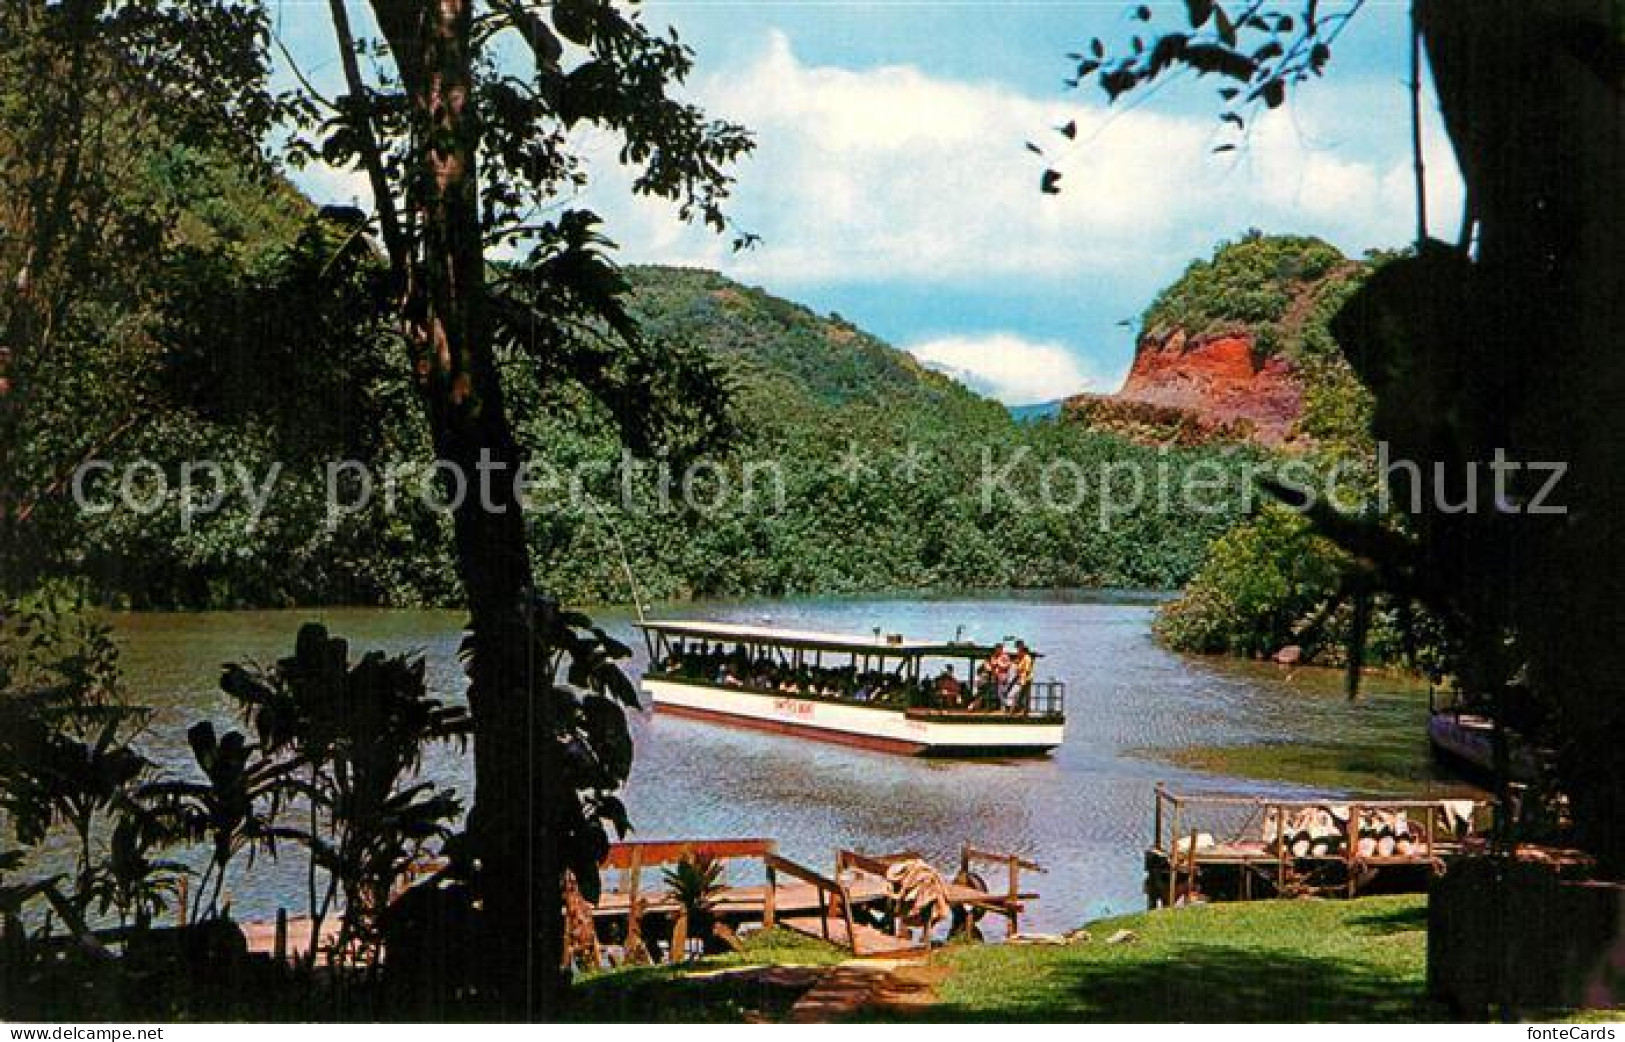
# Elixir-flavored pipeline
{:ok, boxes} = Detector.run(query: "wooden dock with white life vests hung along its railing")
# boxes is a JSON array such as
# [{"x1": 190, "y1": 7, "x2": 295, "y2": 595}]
[{"x1": 1146, "y1": 785, "x2": 1490, "y2": 909}]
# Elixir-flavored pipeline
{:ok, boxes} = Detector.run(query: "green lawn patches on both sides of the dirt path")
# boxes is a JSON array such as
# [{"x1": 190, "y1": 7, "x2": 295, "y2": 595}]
[{"x1": 572, "y1": 896, "x2": 1440, "y2": 1022}]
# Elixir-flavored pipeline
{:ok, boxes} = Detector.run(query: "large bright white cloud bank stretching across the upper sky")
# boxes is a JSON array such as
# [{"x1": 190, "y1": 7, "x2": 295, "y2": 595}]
[{"x1": 588, "y1": 33, "x2": 1461, "y2": 289}]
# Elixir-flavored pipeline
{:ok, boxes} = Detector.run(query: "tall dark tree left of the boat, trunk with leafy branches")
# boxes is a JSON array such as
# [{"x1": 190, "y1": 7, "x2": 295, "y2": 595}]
[{"x1": 287, "y1": 0, "x2": 749, "y2": 1018}]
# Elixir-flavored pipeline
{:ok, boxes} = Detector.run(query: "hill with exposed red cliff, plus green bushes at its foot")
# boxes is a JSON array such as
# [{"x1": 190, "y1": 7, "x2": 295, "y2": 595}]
[{"x1": 1144, "y1": 232, "x2": 1397, "y2": 663}]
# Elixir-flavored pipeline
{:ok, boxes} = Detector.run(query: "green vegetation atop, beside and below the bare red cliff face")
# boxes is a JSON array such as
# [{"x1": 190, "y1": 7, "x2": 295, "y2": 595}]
[{"x1": 1144, "y1": 231, "x2": 1417, "y2": 663}]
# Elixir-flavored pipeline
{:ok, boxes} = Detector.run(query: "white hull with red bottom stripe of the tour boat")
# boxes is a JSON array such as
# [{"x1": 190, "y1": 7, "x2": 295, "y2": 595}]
[{"x1": 644, "y1": 678, "x2": 1066, "y2": 756}]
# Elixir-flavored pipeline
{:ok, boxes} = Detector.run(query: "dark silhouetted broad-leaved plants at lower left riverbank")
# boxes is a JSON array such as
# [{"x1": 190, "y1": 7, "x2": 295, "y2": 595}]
[{"x1": 0, "y1": 598, "x2": 477, "y2": 1016}]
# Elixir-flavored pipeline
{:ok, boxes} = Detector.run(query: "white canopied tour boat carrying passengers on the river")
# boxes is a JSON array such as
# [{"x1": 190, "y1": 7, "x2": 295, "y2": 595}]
[{"x1": 639, "y1": 621, "x2": 1066, "y2": 758}]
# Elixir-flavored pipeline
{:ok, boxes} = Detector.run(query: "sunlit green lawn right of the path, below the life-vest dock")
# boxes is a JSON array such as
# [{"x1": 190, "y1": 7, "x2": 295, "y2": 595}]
[{"x1": 923, "y1": 896, "x2": 1440, "y2": 1022}]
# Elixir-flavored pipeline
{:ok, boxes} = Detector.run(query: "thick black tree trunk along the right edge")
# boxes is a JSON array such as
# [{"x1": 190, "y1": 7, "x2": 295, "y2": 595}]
[{"x1": 1417, "y1": 0, "x2": 1625, "y2": 875}]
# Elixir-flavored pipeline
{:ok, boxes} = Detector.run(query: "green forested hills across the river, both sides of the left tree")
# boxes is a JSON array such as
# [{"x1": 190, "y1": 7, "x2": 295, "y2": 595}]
[{"x1": 0, "y1": 95, "x2": 1258, "y2": 608}]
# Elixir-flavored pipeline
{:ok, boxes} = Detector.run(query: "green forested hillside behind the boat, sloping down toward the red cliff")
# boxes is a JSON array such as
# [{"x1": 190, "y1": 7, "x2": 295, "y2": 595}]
[{"x1": 525, "y1": 267, "x2": 1248, "y2": 600}]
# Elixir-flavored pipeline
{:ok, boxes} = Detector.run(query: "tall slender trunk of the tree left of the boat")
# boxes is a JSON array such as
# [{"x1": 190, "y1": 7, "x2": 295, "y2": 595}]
[{"x1": 374, "y1": 0, "x2": 567, "y2": 1019}]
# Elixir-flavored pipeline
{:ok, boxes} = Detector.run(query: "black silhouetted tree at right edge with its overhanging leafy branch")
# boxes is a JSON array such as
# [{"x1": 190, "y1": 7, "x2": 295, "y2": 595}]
[{"x1": 1045, "y1": 0, "x2": 1625, "y2": 873}]
